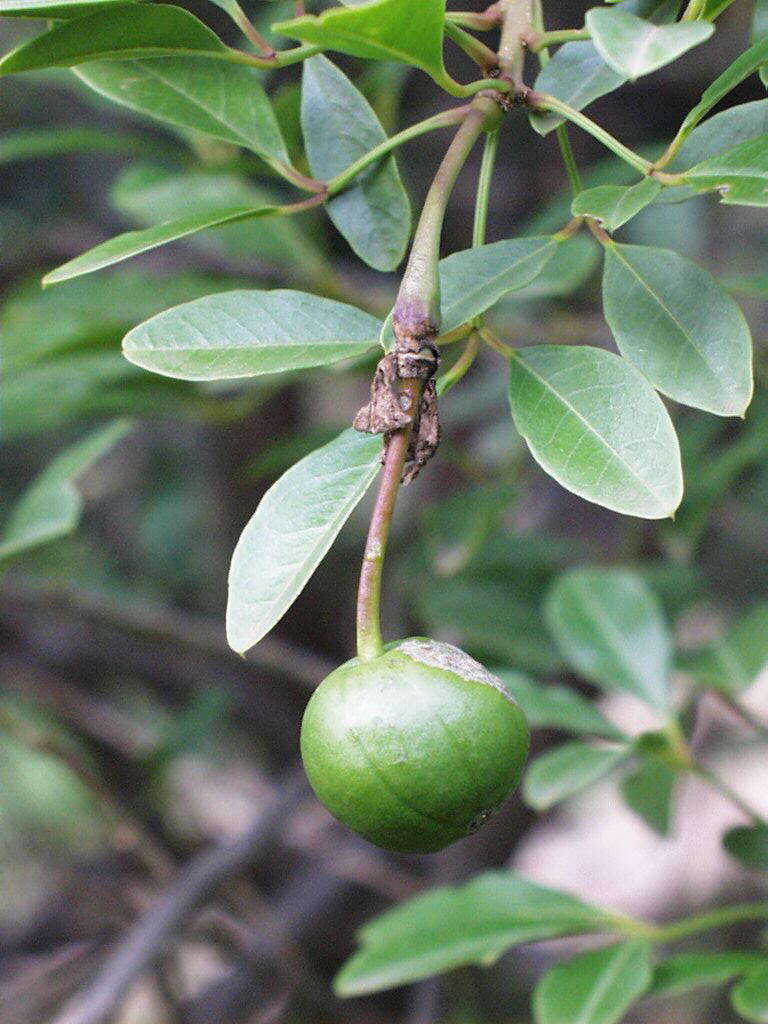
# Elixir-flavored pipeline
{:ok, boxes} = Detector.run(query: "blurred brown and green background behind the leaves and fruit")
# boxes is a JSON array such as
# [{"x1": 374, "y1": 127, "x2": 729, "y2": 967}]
[{"x1": 0, "y1": 0, "x2": 768, "y2": 1024}]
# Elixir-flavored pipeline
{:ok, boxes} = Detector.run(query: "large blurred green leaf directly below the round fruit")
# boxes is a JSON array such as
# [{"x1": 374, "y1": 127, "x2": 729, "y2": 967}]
[{"x1": 335, "y1": 871, "x2": 606, "y2": 995}]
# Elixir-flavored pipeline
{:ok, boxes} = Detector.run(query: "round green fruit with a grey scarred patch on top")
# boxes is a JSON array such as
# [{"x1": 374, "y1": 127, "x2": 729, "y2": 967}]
[{"x1": 301, "y1": 637, "x2": 528, "y2": 853}]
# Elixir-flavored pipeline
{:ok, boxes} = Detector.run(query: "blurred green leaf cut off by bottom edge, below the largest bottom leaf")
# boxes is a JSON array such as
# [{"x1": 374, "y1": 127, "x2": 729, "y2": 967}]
[{"x1": 534, "y1": 939, "x2": 651, "y2": 1024}]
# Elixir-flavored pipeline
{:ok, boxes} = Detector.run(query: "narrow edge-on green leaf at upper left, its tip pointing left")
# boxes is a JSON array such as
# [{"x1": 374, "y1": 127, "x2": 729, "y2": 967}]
[{"x1": 43, "y1": 206, "x2": 278, "y2": 285}]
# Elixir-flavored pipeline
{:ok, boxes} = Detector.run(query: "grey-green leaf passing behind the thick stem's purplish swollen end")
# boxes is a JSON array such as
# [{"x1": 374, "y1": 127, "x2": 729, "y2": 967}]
[{"x1": 381, "y1": 234, "x2": 561, "y2": 350}]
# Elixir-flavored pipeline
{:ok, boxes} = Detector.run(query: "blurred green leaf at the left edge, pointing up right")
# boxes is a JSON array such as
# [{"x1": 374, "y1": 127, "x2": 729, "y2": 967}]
[{"x1": 0, "y1": 423, "x2": 129, "y2": 562}]
